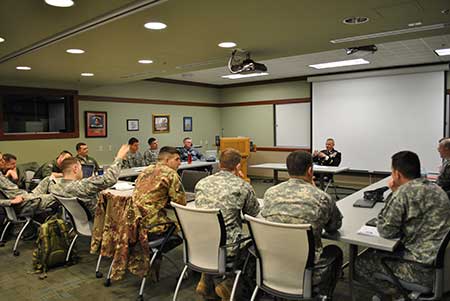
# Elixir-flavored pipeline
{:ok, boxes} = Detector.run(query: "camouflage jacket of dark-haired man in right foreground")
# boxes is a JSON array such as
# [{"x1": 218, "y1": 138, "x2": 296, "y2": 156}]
[{"x1": 377, "y1": 178, "x2": 450, "y2": 264}]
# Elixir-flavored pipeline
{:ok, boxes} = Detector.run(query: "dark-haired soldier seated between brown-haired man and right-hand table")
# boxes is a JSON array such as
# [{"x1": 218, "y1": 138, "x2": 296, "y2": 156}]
[{"x1": 261, "y1": 151, "x2": 343, "y2": 298}]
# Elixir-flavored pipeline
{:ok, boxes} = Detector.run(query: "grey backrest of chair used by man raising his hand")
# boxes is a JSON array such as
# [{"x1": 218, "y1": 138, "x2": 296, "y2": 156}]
[{"x1": 54, "y1": 195, "x2": 92, "y2": 236}]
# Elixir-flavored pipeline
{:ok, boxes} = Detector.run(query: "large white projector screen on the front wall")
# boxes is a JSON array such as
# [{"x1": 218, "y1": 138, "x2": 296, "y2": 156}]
[{"x1": 312, "y1": 71, "x2": 445, "y2": 172}]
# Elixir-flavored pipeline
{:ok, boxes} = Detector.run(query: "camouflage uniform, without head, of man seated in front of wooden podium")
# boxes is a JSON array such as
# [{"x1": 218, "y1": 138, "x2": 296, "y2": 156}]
[{"x1": 195, "y1": 170, "x2": 260, "y2": 255}]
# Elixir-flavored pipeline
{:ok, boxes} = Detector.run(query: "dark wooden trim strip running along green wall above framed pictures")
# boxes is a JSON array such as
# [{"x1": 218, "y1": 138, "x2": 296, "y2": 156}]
[{"x1": 78, "y1": 95, "x2": 311, "y2": 108}]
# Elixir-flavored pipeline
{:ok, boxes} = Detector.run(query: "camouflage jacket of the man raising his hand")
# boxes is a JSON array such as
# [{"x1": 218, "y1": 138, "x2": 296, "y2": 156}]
[{"x1": 33, "y1": 158, "x2": 122, "y2": 213}]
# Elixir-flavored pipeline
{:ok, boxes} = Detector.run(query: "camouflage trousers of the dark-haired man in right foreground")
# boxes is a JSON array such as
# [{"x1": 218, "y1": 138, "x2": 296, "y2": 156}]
[{"x1": 355, "y1": 249, "x2": 433, "y2": 292}]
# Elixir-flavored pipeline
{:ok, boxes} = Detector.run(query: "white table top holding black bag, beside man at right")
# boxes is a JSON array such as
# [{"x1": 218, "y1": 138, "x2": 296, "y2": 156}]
[{"x1": 335, "y1": 177, "x2": 399, "y2": 251}]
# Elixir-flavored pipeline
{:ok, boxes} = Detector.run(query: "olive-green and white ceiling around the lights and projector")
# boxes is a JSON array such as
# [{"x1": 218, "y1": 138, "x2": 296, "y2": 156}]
[{"x1": 0, "y1": 0, "x2": 450, "y2": 89}]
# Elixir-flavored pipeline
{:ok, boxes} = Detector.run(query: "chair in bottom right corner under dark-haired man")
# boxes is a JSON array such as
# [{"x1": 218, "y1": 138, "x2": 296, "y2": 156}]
[{"x1": 374, "y1": 231, "x2": 450, "y2": 300}]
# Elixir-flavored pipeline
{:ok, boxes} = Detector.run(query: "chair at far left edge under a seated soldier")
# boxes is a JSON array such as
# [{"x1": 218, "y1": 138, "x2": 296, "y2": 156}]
[{"x1": 0, "y1": 191, "x2": 46, "y2": 256}]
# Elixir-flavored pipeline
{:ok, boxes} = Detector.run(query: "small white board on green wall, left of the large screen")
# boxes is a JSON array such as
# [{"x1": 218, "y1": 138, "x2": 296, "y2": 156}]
[{"x1": 275, "y1": 102, "x2": 311, "y2": 148}]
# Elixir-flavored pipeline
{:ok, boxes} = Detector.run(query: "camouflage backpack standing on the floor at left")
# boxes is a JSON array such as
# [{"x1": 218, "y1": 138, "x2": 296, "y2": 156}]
[{"x1": 33, "y1": 215, "x2": 70, "y2": 273}]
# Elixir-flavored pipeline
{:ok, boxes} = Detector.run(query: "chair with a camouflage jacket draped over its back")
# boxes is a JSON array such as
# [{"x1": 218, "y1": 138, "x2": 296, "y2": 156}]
[{"x1": 103, "y1": 218, "x2": 182, "y2": 300}]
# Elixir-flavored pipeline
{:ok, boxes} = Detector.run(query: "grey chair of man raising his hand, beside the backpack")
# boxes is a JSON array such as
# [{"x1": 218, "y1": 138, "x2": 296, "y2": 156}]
[{"x1": 54, "y1": 195, "x2": 92, "y2": 262}]
